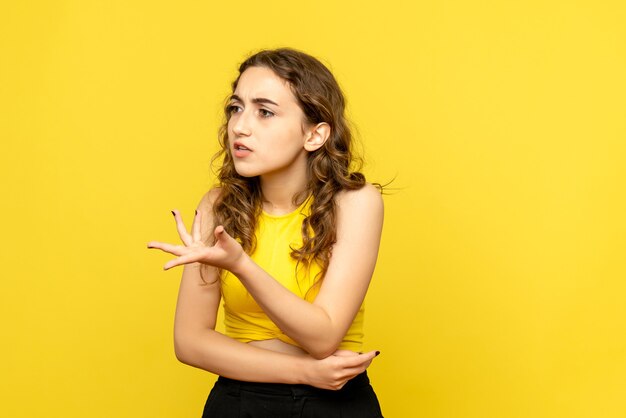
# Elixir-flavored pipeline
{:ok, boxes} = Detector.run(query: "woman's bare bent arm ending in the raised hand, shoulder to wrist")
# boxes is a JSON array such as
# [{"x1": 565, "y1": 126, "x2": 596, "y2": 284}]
[{"x1": 228, "y1": 185, "x2": 383, "y2": 359}]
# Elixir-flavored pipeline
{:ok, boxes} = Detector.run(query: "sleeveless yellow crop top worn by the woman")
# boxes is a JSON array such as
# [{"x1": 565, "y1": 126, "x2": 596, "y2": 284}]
[{"x1": 222, "y1": 199, "x2": 364, "y2": 352}]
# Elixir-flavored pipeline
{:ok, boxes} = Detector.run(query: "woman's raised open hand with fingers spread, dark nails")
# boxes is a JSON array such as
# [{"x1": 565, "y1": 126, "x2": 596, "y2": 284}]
[{"x1": 148, "y1": 211, "x2": 246, "y2": 271}]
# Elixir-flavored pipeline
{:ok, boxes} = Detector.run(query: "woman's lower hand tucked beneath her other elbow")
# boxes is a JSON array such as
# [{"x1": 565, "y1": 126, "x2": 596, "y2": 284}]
[{"x1": 304, "y1": 350, "x2": 380, "y2": 390}]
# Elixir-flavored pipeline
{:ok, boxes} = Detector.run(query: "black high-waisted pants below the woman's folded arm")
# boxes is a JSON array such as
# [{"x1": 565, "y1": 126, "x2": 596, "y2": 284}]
[{"x1": 202, "y1": 372, "x2": 382, "y2": 418}]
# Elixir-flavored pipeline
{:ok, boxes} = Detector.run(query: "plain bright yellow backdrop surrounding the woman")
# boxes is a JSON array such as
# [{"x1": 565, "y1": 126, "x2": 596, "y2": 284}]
[{"x1": 0, "y1": 0, "x2": 626, "y2": 418}]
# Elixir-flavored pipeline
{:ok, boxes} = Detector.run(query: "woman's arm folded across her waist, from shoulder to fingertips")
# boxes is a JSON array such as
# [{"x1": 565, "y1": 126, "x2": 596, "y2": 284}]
[{"x1": 154, "y1": 191, "x2": 375, "y2": 389}]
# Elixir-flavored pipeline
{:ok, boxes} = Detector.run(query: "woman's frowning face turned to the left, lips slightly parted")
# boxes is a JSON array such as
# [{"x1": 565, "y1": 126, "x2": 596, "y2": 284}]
[{"x1": 228, "y1": 67, "x2": 307, "y2": 177}]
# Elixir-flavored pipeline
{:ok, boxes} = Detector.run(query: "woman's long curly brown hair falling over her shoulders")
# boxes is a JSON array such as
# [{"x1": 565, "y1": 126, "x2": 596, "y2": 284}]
[{"x1": 212, "y1": 48, "x2": 365, "y2": 277}]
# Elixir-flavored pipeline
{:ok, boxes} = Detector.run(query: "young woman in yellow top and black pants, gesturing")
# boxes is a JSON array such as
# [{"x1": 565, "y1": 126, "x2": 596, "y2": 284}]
[{"x1": 148, "y1": 48, "x2": 383, "y2": 418}]
